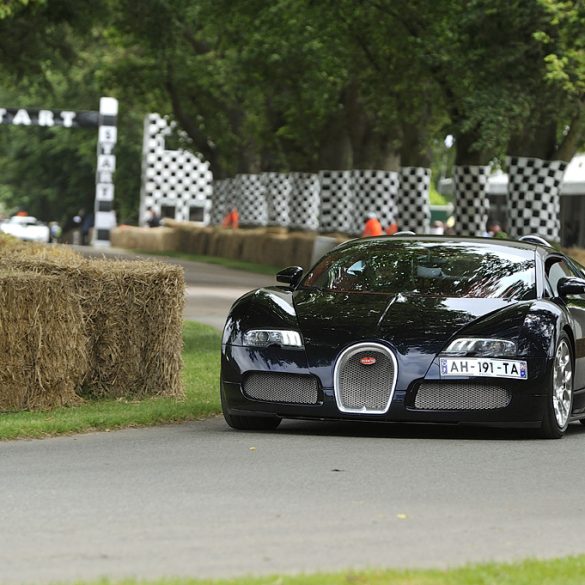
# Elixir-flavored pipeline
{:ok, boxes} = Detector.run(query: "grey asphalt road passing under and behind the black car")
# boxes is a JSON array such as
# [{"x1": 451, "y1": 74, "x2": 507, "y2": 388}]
[{"x1": 0, "y1": 249, "x2": 585, "y2": 585}]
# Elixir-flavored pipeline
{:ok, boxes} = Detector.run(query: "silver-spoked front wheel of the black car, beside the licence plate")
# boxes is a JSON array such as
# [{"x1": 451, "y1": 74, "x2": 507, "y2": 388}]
[{"x1": 540, "y1": 335, "x2": 573, "y2": 439}]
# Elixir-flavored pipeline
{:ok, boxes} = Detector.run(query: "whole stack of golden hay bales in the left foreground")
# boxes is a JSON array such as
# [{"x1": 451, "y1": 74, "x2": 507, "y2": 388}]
[{"x1": 0, "y1": 237, "x2": 184, "y2": 410}]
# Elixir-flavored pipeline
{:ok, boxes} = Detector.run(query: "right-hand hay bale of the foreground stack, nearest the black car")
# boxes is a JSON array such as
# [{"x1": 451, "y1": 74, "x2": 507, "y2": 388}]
[{"x1": 84, "y1": 260, "x2": 185, "y2": 398}]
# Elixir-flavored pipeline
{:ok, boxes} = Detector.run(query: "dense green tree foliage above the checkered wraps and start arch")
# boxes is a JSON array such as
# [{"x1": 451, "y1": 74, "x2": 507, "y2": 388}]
[{"x1": 0, "y1": 0, "x2": 585, "y2": 222}]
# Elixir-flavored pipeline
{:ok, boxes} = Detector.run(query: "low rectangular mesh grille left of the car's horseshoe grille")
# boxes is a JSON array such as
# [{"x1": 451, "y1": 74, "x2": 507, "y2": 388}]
[{"x1": 244, "y1": 373, "x2": 319, "y2": 404}]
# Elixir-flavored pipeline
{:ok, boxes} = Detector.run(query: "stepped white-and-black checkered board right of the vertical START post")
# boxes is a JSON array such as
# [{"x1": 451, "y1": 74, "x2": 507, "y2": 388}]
[{"x1": 140, "y1": 114, "x2": 213, "y2": 224}]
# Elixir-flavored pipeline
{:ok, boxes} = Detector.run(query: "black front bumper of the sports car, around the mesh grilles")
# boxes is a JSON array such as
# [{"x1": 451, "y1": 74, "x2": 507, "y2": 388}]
[{"x1": 221, "y1": 347, "x2": 551, "y2": 426}]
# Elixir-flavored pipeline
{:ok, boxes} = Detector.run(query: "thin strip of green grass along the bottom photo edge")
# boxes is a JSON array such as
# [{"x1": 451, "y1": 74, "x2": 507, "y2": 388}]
[{"x1": 34, "y1": 555, "x2": 585, "y2": 585}]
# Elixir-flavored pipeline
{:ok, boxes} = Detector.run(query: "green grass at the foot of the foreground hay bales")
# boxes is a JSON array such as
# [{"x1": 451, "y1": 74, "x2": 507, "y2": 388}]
[{"x1": 0, "y1": 321, "x2": 221, "y2": 440}]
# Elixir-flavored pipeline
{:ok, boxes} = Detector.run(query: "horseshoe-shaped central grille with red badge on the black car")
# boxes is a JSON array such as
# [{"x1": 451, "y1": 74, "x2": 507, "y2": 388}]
[{"x1": 334, "y1": 343, "x2": 397, "y2": 414}]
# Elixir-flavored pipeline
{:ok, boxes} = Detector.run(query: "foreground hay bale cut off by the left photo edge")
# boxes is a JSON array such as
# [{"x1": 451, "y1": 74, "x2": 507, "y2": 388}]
[{"x1": 0, "y1": 270, "x2": 88, "y2": 411}]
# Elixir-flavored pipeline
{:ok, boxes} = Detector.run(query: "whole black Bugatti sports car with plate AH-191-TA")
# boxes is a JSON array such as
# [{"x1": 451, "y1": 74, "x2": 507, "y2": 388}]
[{"x1": 221, "y1": 235, "x2": 585, "y2": 438}]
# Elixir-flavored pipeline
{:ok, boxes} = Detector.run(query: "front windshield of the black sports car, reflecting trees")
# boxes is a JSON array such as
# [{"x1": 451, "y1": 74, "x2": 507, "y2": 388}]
[{"x1": 301, "y1": 240, "x2": 536, "y2": 299}]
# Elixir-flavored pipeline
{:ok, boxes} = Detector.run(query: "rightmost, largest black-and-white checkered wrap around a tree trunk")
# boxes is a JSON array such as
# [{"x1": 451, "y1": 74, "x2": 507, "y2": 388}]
[{"x1": 507, "y1": 157, "x2": 567, "y2": 242}]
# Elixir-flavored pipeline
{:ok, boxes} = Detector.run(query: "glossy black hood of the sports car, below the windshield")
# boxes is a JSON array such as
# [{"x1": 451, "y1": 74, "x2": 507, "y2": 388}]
[{"x1": 293, "y1": 290, "x2": 527, "y2": 386}]
